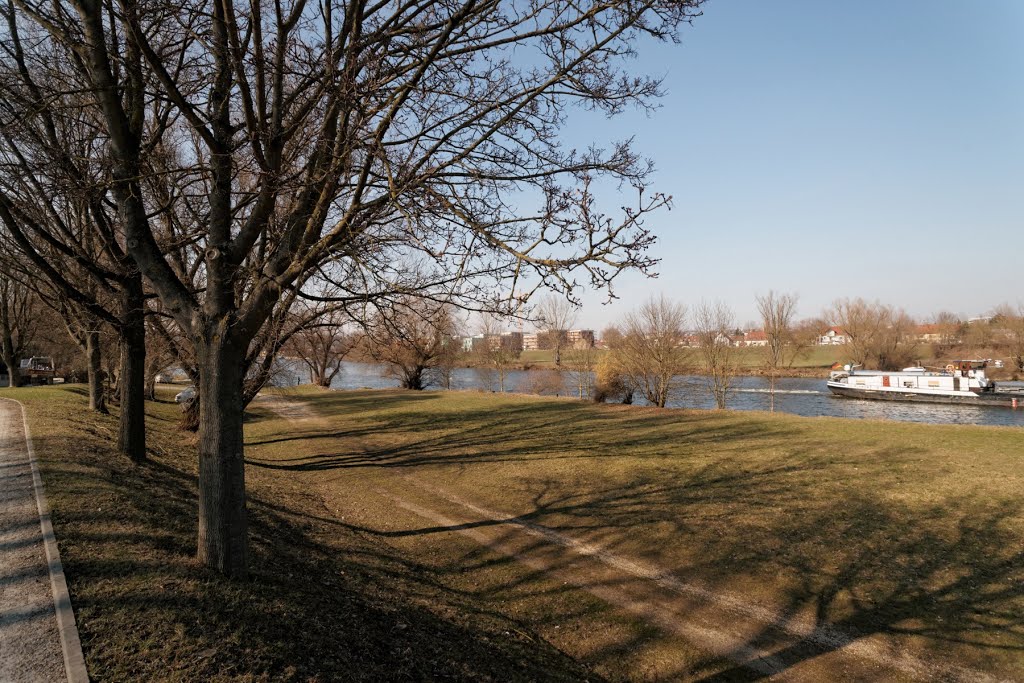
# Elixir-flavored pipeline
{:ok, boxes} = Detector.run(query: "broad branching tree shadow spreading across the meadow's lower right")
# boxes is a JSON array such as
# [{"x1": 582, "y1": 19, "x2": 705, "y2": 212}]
[{"x1": 387, "y1": 468, "x2": 1024, "y2": 681}]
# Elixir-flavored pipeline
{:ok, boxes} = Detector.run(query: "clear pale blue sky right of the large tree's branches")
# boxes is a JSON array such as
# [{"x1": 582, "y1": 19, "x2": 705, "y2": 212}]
[{"x1": 569, "y1": 0, "x2": 1024, "y2": 329}]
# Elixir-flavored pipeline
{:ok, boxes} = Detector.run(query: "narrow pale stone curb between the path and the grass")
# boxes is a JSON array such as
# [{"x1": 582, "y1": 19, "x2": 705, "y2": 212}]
[{"x1": 8, "y1": 398, "x2": 89, "y2": 683}]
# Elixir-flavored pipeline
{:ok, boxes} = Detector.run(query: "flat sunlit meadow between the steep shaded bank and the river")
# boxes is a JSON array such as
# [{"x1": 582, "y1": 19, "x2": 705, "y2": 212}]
[{"x1": 249, "y1": 391, "x2": 1024, "y2": 679}]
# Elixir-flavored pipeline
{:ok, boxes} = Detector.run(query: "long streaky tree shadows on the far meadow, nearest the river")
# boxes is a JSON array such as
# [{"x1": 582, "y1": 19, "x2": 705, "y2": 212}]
[{"x1": 247, "y1": 395, "x2": 787, "y2": 471}]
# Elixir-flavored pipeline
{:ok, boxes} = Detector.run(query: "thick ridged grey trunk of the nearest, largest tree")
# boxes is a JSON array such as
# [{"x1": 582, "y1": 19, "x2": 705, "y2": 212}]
[{"x1": 197, "y1": 323, "x2": 248, "y2": 578}]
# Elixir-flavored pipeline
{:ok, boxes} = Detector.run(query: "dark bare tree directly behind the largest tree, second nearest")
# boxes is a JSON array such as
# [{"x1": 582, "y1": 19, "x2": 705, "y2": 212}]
[{"x1": 0, "y1": 104, "x2": 146, "y2": 462}]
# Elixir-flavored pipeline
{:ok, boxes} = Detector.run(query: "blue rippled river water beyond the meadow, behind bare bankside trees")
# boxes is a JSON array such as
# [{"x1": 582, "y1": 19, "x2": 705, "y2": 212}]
[{"x1": 278, "y1": 362, "x2": 1024, "y2": 427}]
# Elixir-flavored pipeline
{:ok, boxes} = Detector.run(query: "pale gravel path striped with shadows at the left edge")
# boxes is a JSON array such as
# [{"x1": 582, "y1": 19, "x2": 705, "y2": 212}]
[{"x1": 0, "y1": 399, "x2": 67, "y2": 683}]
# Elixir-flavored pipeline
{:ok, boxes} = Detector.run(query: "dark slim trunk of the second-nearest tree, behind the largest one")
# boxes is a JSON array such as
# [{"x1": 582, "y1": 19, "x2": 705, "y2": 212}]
[{"x1": 118, "y1": 274, "x2": 145, "y2": 462}]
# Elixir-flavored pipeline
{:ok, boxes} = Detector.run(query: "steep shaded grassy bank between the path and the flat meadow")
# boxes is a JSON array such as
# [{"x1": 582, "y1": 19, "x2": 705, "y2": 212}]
[{"x1": 0, "y1": 386, "x2": 587, "y2": 681}]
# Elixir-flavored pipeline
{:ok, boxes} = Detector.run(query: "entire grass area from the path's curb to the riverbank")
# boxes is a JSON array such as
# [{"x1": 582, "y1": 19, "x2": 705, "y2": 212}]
[{"x1": 0, "y1": 388, "x2": 1024, "y2": 681}]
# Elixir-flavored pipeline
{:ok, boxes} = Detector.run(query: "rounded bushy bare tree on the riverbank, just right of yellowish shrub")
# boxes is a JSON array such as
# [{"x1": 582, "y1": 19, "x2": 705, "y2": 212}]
[{"x1": 610, "y1": 295, "x2": 687, "y2": 408}]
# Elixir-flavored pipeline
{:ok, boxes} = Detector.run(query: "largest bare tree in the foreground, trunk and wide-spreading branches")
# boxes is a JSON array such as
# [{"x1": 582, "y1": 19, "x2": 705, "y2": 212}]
[{"x1": 3, "y1": 0, "x2": 699, "y2": 575}]
